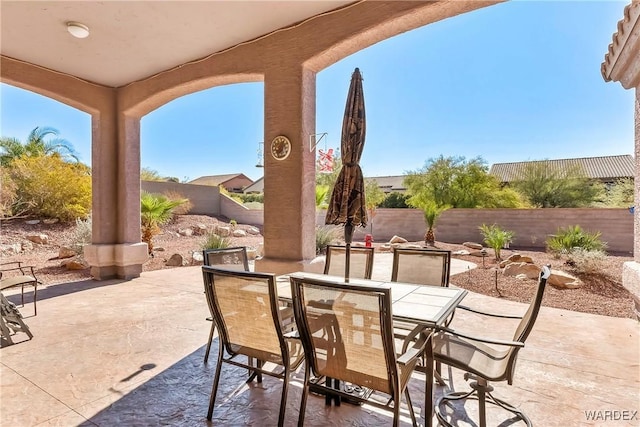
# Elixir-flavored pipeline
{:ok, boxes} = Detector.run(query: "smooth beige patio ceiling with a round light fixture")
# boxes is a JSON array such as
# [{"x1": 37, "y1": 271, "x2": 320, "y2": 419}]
[{"x1": 0, "y1": 0, "x2": 354, "y2": 87}]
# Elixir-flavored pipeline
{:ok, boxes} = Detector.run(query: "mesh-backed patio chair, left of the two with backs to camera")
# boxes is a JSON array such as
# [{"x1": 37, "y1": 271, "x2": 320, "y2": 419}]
[{"x1": 202, "y1": 266, "x2": 304, "y2": 426}]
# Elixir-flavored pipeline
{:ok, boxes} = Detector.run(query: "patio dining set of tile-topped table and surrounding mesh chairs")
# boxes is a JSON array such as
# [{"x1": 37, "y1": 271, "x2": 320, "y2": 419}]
[{"x1": 202, "y1": 246, "x2": 550, "y2": 426}]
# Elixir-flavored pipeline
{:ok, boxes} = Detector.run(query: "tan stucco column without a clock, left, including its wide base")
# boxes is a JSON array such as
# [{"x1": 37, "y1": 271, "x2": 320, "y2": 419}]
[{"x1": 84, "y1": 107, "x2": 148, "y2": 280}]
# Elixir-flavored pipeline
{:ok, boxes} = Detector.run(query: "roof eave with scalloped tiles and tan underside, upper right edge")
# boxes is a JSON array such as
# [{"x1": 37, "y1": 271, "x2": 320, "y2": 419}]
[{"x1": 600, "y1": 0, "x2": 640, "y2": 89}]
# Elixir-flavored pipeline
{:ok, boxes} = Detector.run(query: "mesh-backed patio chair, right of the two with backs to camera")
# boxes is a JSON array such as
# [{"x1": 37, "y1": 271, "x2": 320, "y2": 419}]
[{"x1": 291, "y1": 277, "x2": 427, "y2": 426}]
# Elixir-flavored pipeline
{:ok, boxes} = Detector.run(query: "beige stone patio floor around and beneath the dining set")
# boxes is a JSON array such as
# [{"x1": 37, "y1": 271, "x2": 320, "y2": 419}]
[{"x1": 0, "y1": 261, "x2": 640, "y2": 427}]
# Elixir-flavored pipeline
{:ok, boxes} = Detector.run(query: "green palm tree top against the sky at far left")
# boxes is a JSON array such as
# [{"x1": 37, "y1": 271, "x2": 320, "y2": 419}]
[{"x1": 0, "y1": 126, "x2": 79, "y2": 166}]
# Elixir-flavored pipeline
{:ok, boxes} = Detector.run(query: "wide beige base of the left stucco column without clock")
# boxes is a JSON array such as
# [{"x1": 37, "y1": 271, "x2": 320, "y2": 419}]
[{"x1": 84, "y1": 243, "x2": 149, "y2": 280}]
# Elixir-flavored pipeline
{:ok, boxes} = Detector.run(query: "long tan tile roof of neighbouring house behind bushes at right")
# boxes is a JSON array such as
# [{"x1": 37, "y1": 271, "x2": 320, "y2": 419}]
[{"x1": 489, "y1": 154, "x2": 635, "y2": 184}]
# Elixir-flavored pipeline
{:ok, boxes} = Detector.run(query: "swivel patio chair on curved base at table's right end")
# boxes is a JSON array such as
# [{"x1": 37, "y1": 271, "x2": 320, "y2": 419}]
[{"x1": 433, "y1": 266, "x2": 551, "y2": 427}]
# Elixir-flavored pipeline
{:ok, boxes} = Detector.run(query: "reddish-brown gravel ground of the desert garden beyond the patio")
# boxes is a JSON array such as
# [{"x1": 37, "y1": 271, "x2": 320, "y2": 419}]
[{"x1": 0, "y1": 215, "x2": 635, "y2": 318}]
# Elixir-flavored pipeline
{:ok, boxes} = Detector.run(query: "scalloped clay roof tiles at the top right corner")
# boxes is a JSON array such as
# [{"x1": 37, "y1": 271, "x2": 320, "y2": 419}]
[{"x1": 600, "y1": 0, "x2": 640, "y2": 89}]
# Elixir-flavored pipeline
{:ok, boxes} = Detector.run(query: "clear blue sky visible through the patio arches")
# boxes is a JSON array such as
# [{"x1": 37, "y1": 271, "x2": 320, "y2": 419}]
[{"x1": 0, "y1": 1, "x2": 634, "y2": 180}]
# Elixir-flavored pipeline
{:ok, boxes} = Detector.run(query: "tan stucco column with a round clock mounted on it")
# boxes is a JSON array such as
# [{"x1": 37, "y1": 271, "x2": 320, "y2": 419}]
[{"x1": 256, "y1": 63, "x2": 316, "y2": 273}]
